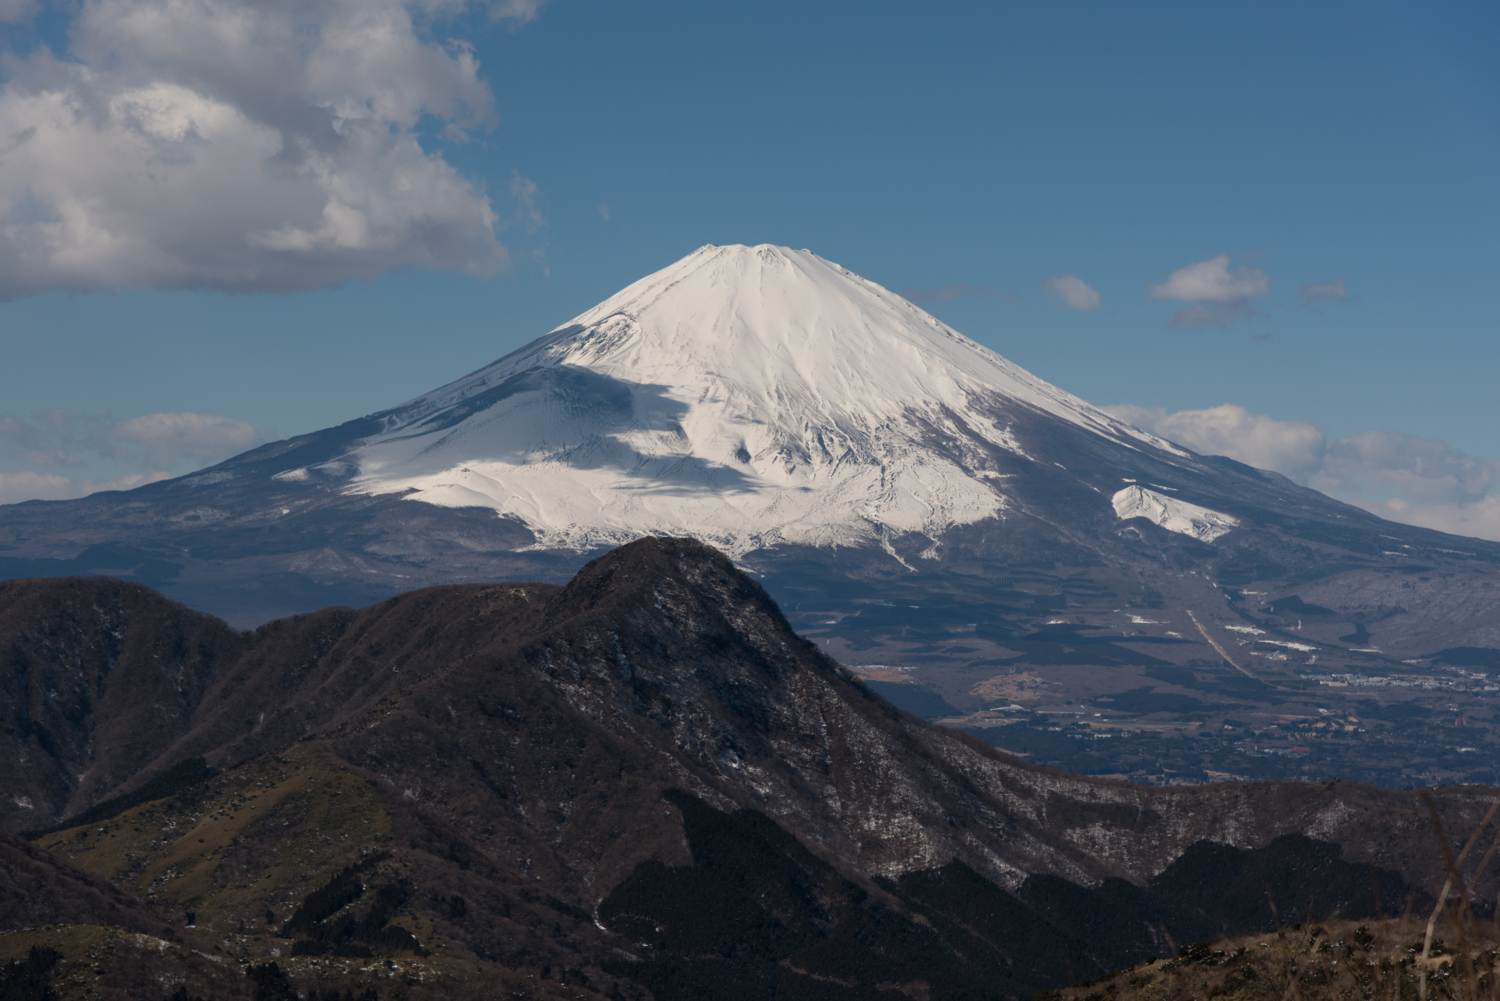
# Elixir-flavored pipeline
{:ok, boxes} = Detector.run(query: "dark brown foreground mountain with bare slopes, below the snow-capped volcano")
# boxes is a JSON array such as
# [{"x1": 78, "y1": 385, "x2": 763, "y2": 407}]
[{"x1": 0, "y1": 549, "x2": 1493, "y2": 998}]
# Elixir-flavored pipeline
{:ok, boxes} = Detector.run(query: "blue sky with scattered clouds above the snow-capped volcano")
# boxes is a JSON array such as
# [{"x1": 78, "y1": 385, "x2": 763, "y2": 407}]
[{"x1": 0, "y1": 0, "x2": 1500, "y2": 537}]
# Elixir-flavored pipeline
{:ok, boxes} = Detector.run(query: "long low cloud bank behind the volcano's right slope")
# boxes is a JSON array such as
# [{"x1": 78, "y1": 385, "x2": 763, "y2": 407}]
[{"x1": 1104, "y1": 404, "x2": 1500, "y2": 540}]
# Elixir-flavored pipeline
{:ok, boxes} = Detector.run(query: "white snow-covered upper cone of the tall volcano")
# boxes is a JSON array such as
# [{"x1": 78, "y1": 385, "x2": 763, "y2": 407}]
[{"x1": 345, "y1": 245, "x2": 1185, "y2": 555}]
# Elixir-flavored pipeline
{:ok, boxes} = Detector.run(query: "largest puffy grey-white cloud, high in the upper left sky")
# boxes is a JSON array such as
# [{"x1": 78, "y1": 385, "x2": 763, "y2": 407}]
[{"x1": 0, "y1": 0, "x2": 542, "y2": 299}]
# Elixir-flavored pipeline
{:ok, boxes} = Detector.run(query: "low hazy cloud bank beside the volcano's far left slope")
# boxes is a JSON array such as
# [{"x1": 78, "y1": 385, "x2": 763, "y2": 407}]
[{"x1": 0, "y1": 410, "x2": 266, "y2": 471}]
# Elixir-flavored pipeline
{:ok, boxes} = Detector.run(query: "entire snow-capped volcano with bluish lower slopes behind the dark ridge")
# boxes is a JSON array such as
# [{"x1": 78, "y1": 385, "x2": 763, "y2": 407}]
[{"x1": 0, "y1": 246, "x2": 1500, "y2": 774}]
